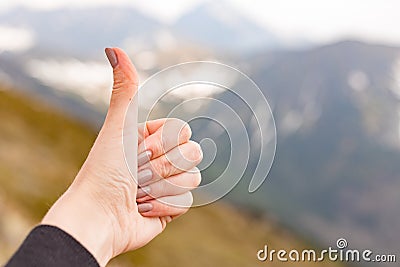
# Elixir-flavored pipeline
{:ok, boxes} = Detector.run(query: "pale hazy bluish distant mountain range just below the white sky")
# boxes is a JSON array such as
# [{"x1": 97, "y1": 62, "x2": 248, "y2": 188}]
[{"x1": 0, "y1": 5, "x2": 279, "y2": 59}]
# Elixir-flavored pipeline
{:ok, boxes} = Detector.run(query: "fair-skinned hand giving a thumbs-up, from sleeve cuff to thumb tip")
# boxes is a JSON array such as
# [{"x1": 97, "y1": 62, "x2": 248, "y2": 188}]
[{"x1": 42, "y1": 48, "x2": 202, "y2": 266}]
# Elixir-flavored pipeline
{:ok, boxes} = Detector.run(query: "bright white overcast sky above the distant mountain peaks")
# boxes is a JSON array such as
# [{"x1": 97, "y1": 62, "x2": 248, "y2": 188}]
[{"x1": 0, "y1": 0, "x2": 400, "y2": 45}]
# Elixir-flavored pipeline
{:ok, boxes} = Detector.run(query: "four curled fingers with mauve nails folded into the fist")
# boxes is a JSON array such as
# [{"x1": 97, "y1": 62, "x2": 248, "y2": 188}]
[{"x1": 136, "y1": 119, "x2": 202, "y2": 217}]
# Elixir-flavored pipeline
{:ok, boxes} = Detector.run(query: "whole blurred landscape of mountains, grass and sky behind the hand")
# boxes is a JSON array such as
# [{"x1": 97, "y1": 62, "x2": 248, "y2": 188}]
[{"x1": 0, "y1": 0, "x2": 400, "y2": 266}]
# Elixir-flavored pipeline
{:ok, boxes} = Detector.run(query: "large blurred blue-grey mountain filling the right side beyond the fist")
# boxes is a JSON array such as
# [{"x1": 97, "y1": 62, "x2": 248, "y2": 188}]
[{"x1": 194, "y1": 41, "x2": 400, "y2": 264}]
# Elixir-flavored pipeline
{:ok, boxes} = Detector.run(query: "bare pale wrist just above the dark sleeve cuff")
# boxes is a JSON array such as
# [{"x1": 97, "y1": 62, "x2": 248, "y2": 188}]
[{"x1": 41, "y1": 187, "x2": 114, "y2": 266}]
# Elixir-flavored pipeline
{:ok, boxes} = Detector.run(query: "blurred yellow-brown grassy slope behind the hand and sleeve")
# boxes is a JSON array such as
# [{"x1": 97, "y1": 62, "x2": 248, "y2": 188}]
[{"x1": 0, "y1": 88, "x2": 344, "y2": 267}]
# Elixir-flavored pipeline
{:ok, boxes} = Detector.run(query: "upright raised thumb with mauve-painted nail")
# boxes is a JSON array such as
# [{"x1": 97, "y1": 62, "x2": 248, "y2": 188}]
[{"x1": 105, "y1": 48, "x2": 139, "y2": 129}]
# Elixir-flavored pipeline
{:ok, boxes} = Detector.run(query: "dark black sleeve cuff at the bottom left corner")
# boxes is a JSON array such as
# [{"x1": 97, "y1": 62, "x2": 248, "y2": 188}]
[{"x1": 6, "y1": 225, "x2": 99, "y2": 267}]
